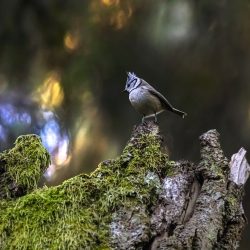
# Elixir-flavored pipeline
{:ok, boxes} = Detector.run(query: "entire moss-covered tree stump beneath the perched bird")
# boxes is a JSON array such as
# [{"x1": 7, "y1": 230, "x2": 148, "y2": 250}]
[{"x1": 0, "y1": 122, "x2": 248, "y2": 249}]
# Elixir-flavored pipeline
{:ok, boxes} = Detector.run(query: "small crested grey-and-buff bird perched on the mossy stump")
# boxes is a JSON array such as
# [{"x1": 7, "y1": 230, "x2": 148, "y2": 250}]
[{"x1": 124, "y1": 72, "x2": 187, "y2": 123}]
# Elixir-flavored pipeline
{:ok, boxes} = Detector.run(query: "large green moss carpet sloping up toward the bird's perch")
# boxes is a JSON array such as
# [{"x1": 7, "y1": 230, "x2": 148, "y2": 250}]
[{"x1": 0, "y1": 128, "x2": 172, "y2": 249}]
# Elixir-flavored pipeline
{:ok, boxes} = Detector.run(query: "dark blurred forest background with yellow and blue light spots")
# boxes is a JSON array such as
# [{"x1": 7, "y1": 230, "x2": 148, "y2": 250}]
[{"x1": 0, "y1": 0, "x2": 250, "y2": 246}]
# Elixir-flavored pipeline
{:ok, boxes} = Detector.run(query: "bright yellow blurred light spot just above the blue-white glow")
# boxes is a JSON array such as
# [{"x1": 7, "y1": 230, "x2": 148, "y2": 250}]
[{"x1": 35, "y1": 72, "x2": 64, "y2": 109}]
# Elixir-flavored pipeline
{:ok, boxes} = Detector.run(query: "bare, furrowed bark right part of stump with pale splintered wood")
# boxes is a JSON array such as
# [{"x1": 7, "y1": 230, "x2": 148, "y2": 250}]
[{"x1": 148, "y1": 130, "x2": 249, "y2": 249}]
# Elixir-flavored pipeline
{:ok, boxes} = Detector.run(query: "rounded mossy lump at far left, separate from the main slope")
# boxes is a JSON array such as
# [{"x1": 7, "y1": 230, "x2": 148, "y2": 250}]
[{"x1": 0, "y1": 135, "x2": 50, "y2": 198}]
